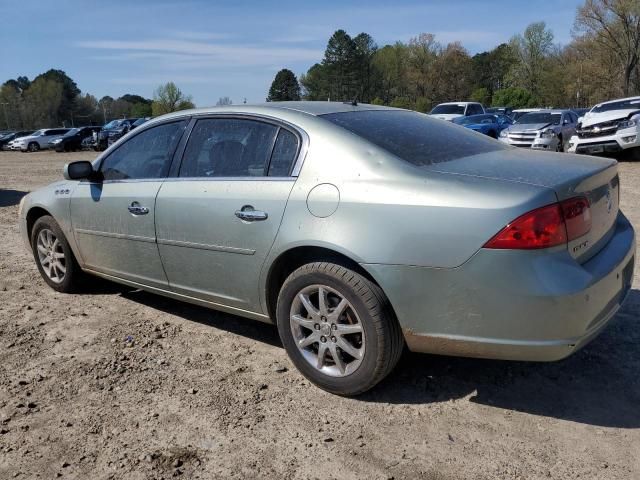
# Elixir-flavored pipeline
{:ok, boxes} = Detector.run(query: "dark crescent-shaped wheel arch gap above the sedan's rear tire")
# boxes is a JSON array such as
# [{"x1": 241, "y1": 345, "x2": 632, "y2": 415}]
[{"x1": 265, "y1": 245, "x2": 382, "y2": 323}]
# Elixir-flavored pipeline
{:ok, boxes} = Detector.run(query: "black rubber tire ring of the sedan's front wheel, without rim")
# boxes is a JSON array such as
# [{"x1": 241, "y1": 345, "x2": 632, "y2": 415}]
[{"x1": 31, "y1": 215, "x2": 82, "y2": 293}]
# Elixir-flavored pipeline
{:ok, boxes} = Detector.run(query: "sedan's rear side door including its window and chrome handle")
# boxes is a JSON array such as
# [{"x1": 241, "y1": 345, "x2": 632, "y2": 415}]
[{"x1": 156, "y1": 117, "x2": 301, "y2": 313}]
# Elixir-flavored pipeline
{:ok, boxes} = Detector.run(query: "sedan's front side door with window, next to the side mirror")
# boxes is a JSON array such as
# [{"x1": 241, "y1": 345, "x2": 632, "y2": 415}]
[{"x1": 71, "y1": 120, "x2": 187, "y2": 288}]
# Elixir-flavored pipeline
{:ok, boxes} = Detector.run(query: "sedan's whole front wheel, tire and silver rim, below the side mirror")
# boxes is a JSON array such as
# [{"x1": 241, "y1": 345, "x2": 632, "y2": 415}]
[{"x1": 31, "y1": 215, "x2": 82, "y2": 293}]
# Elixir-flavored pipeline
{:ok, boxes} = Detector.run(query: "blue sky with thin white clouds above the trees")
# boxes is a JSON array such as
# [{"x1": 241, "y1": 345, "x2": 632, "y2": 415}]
[{"x1": 0, "y1": 0, "x2": 583, "y2": 106}]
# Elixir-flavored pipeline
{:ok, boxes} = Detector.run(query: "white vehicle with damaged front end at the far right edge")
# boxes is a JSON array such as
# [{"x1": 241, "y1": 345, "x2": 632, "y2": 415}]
[{"x1": 569, "y1": 97, "x2": 640, "y2": 156}]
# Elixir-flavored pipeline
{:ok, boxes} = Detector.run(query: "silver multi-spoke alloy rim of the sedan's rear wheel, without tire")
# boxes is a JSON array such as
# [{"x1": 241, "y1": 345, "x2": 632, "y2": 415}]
[{"x1": 289, "y1": 285, "x2": 365, "y2": 377}]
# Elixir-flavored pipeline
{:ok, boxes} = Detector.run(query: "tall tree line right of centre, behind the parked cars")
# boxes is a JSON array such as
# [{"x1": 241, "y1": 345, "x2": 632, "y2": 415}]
[{"x1": 267, "y1": 0, "x2": 640, "y2": 112}]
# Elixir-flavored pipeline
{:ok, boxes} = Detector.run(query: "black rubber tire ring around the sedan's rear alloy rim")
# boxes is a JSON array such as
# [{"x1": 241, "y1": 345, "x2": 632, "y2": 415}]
[{"x1": 276, "y1": 262, "x2": 404, "y2": 396}]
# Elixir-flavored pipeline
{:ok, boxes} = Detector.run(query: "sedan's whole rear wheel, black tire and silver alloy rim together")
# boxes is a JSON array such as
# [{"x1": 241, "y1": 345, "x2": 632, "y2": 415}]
[{"x1": 277, "y1": 262, "x2": 404, "y2": 395}]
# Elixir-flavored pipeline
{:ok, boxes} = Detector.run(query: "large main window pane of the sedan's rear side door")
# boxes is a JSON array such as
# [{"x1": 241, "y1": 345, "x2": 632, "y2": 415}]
[{"x1": 179, "y1": 118, "x2": 278, "y2": 178}]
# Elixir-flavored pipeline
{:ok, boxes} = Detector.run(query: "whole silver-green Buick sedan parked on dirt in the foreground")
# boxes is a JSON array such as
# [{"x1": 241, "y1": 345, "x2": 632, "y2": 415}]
[{"x1": 20, "y1": 102, "x2": 635, "y2": 395}]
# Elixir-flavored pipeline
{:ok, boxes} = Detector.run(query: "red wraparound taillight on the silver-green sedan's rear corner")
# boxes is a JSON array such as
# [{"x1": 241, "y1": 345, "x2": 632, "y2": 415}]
[{"x1": 484, "y1": 197, "x2": 591, "y2": 250}]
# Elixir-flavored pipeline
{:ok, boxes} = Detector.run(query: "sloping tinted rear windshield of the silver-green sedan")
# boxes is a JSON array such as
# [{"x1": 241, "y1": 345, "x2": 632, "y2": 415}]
[{"x1": 321, "y1": 110, "x2": 509, "y2": 166}]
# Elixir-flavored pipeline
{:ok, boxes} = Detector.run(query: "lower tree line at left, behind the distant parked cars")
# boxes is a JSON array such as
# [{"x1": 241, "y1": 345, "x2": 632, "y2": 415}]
[{"x1": 0, "y1": 69, "x2": 194, "y2": 130}]
